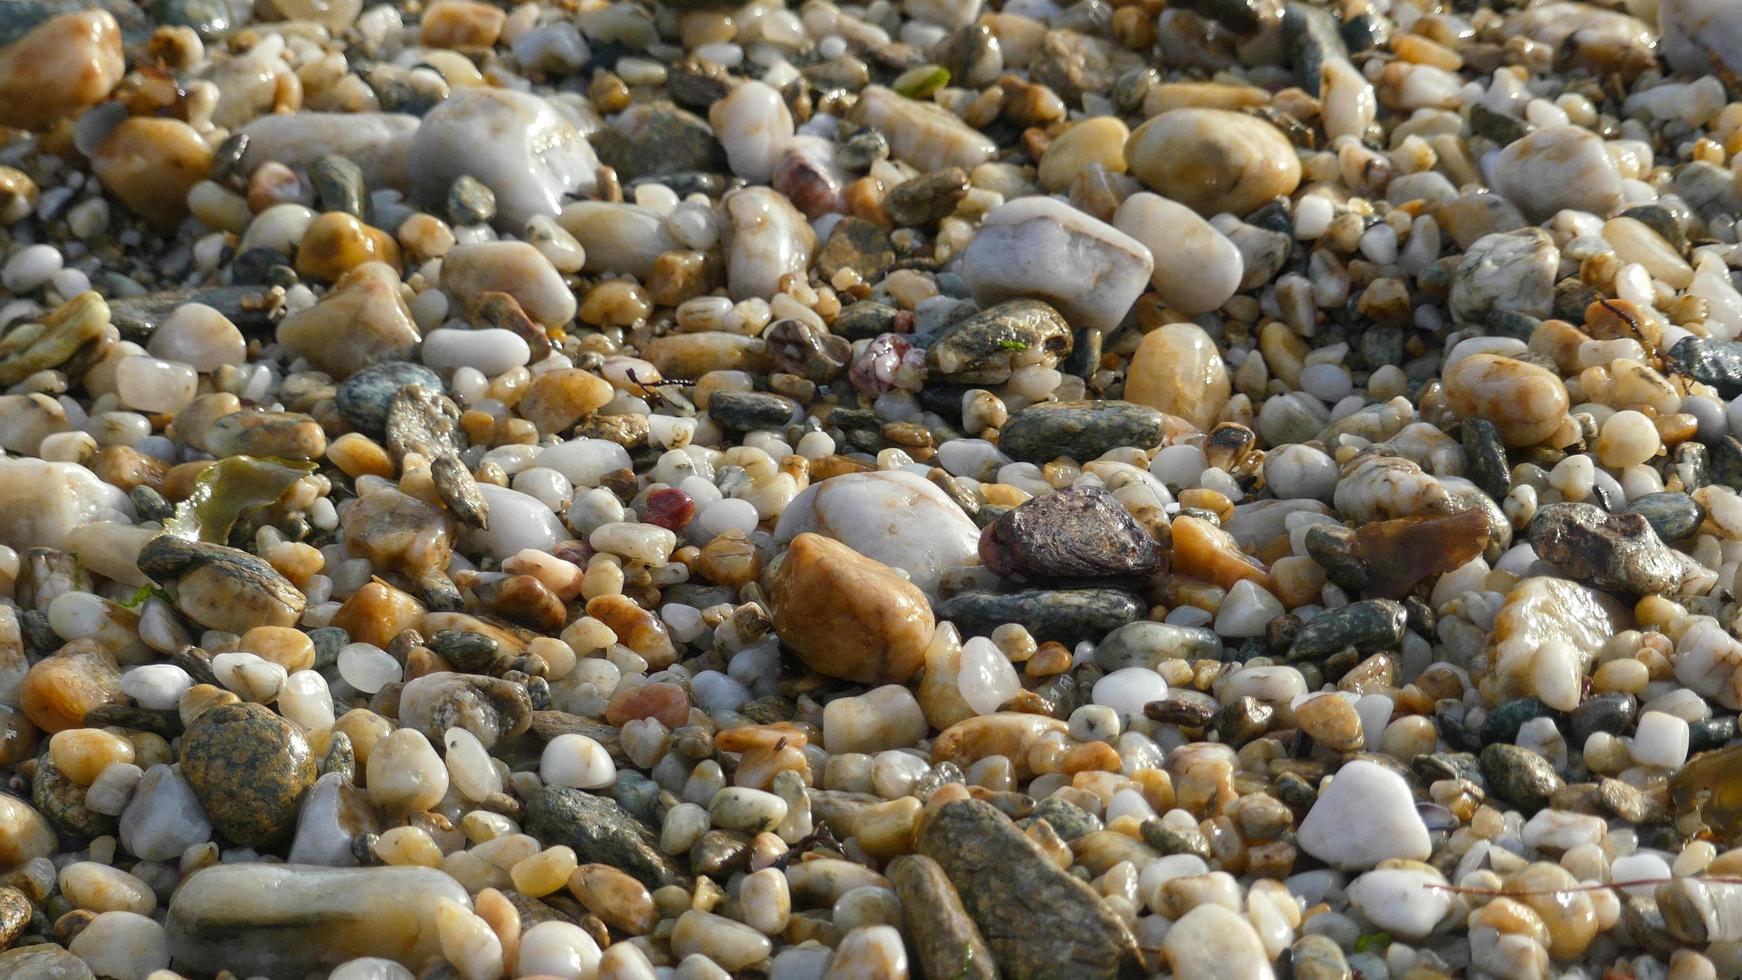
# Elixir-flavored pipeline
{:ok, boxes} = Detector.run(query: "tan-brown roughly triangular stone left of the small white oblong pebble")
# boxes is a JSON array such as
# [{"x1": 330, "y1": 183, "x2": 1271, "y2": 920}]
[{"x1": 277, "y1": 263, "x2": 426, "y2": 379}]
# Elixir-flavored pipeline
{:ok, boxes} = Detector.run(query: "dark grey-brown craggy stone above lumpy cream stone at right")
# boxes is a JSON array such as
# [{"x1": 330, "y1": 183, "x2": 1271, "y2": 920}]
[{"x1": 1529, "y1": 500, "x2": 1691, "y2": 595}]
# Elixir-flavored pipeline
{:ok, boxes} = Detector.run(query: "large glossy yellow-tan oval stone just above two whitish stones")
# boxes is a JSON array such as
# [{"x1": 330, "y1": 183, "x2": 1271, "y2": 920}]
[{"x1": 1125, "y1": 108, "x2": 1301, "y2": 218}]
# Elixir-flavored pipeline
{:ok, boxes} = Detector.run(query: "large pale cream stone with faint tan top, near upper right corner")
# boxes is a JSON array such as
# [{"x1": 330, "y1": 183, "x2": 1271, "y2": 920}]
[{"x1": 1489, "y1": 125, "x2": 1624, "y2": 221}]
